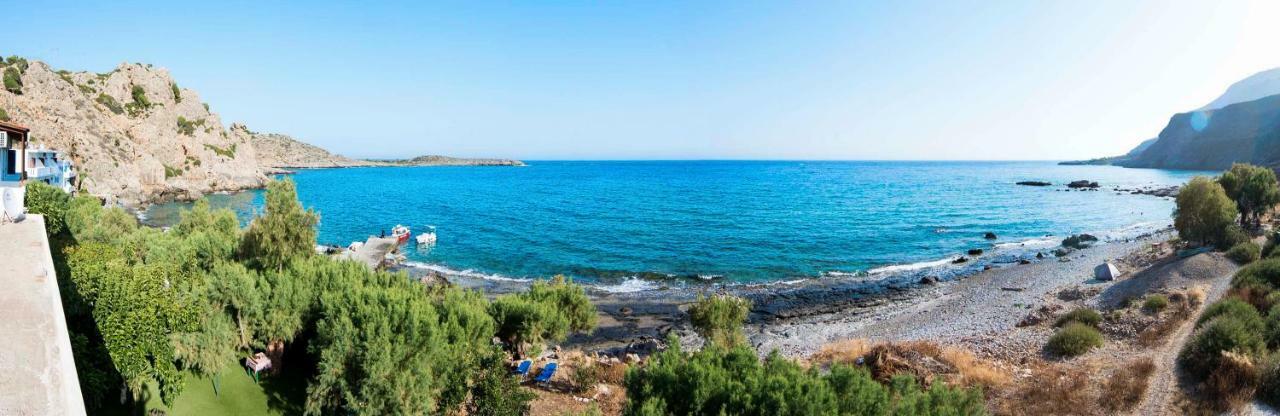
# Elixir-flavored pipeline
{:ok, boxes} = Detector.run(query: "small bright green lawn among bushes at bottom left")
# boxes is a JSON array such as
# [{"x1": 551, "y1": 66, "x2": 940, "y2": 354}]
[{"x1": 101, "y1": 366, "x2": 306, "y2": 416}]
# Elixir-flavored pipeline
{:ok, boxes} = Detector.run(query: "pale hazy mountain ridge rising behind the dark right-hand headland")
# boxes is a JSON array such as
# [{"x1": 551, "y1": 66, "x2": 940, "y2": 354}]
[{"x1": 1061, "y1": 68, "x2": 1280, "y2": 169}]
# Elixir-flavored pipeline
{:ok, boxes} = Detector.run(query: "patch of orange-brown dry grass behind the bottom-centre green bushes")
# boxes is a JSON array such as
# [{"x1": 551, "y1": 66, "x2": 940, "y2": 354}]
[{"x1": 809, "y1": 339, "x2": 1010, "y2": 387}]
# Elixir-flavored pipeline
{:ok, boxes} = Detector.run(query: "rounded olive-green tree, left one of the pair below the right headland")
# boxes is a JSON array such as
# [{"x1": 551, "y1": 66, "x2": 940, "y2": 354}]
[{"x1": 1174, "y1": 177, "x2": 1238, "y2": 243}]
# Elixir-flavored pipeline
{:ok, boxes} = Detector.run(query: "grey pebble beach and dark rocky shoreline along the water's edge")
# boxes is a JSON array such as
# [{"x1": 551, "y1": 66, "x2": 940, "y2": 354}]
[{"x1": 396, "y1": 227, "x2": 1174, "y2": 357}]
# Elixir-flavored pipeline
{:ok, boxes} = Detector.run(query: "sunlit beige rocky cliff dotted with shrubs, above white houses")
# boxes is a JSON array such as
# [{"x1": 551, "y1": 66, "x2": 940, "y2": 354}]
[{"x1": 0, "y1": 59, "x2": 266, "y2": 205}]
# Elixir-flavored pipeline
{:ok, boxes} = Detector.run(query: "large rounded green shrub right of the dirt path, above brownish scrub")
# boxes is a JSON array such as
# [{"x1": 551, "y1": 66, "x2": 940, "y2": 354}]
[{"x1": 1178, "y1": 314, "x2": 1266, "y2": 380}]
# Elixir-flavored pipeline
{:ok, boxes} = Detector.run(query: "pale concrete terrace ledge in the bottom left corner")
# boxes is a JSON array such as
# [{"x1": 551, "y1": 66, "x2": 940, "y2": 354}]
[{"x1": 0, "y1": 215, "x2": 84, "y2": 415}]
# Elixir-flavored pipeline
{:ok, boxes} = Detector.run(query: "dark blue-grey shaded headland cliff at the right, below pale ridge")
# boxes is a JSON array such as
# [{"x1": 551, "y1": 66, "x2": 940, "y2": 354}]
[{"x1": 1116, "y1": 95, "x2": 1280, "y2": 170}]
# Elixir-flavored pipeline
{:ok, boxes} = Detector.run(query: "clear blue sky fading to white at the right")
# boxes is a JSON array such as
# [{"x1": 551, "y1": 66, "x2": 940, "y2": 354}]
[{"x1": 0, "y1": 0, "x2": 1280, "y2": 160}]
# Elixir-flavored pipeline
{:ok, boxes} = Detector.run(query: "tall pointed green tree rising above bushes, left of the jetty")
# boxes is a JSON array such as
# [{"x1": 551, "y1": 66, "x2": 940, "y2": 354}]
[{"x1": 241, "y1": 179, "x2": 320, "y2": 271}]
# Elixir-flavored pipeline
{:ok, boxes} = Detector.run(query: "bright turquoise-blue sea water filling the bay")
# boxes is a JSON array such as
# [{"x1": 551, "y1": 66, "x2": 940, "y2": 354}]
[{"x1": 146, "y1": 161, "x2": 1204, "y2": 291}]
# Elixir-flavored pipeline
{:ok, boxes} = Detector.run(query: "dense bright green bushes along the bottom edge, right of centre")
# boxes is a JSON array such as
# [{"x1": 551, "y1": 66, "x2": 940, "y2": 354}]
[{"x1": 623, "y1": 339, "x2": 986, "y2": 415}]
